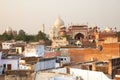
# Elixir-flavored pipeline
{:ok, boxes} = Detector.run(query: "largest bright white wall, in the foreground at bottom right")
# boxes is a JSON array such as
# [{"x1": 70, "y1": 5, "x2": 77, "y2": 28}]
[{"x1": 70, "y1": 68, "x2": 112, "y2": 80}]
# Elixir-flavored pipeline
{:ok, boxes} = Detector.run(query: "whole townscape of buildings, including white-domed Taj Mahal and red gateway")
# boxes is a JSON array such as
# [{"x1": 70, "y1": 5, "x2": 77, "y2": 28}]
[{"x1": 0, "y1": 18, "x2": 120, "y2": 80}]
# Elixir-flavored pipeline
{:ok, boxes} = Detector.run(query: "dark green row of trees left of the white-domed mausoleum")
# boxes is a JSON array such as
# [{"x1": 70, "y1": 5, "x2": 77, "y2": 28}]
[{"x1": 0, "y1": 30, "x2": 48, "y2": 42}]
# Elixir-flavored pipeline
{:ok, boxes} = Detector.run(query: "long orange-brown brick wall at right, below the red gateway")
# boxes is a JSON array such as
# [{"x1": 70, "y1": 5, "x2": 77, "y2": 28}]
[{"x1": 68, "y1": 43, "x2": 120, "y2": 62}]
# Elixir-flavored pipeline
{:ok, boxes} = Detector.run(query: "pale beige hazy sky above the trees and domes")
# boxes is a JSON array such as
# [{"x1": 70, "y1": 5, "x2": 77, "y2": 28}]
[{"x1": 0, "y1": 0, "x2": 120, "y2": 34}]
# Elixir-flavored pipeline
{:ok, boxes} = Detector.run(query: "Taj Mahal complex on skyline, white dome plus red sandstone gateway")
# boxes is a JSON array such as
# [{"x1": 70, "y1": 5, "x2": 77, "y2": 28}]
[{"x1": 49, "y1": 17, "x2": 115, "y2": 46}]
